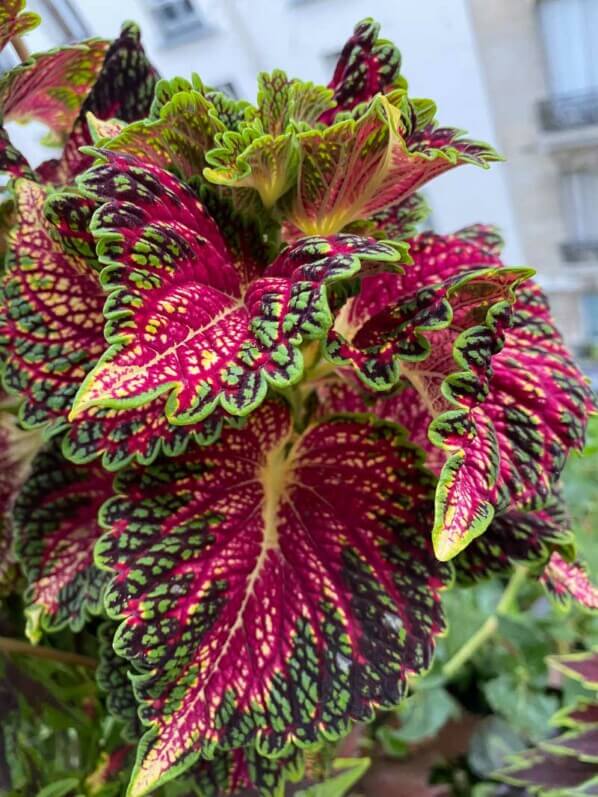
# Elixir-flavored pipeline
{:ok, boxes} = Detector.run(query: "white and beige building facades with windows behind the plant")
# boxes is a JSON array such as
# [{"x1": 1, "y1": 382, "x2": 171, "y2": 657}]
[{"x1": 5, "y1": 0, "x2": 598, "y2": 351}]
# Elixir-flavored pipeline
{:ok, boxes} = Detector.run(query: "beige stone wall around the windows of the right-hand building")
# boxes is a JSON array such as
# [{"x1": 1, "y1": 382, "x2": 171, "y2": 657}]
[{"x1": 469, "y1": 0, "x2": 598, "y2": 346}]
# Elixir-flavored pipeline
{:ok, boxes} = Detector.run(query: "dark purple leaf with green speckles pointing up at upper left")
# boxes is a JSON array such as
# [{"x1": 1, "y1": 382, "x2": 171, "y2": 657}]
[{"x1": 38, "y1": 22, "x2": 158, "y2": 185}]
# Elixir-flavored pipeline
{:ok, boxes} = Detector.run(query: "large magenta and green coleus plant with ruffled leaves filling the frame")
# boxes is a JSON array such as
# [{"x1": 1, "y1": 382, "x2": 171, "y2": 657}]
[{"x1": 0, "y1": 2, "x2": 596, "y2": 797}]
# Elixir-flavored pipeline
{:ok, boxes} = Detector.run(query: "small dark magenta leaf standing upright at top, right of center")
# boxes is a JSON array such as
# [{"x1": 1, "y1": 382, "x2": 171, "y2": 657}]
[{"x1": 320, "y1": 18, "x2": 401, "y2": 124}]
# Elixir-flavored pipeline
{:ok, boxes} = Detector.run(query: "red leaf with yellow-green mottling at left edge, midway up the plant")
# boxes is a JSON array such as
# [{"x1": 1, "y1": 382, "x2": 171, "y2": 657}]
[{"x1": 0, "y1": 180, "x2": 105, "y2": 434}]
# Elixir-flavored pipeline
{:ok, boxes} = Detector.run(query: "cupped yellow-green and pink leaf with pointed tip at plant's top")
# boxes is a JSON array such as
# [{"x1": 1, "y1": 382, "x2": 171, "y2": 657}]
[{"x1": 277, "y1": 90, "x2": 498, "y2": 235}]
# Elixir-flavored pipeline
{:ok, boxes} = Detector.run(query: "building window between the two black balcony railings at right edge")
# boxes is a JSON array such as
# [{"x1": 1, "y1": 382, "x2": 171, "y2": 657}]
[{"x1": 562, "y1": 169, "x2": 598, "y2": 261}]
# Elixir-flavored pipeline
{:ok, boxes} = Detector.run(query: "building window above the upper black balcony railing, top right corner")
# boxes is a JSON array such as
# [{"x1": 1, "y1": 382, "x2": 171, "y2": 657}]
[{"x1": 538, "y1": 0, "x2": 598, "y2": 95}]
